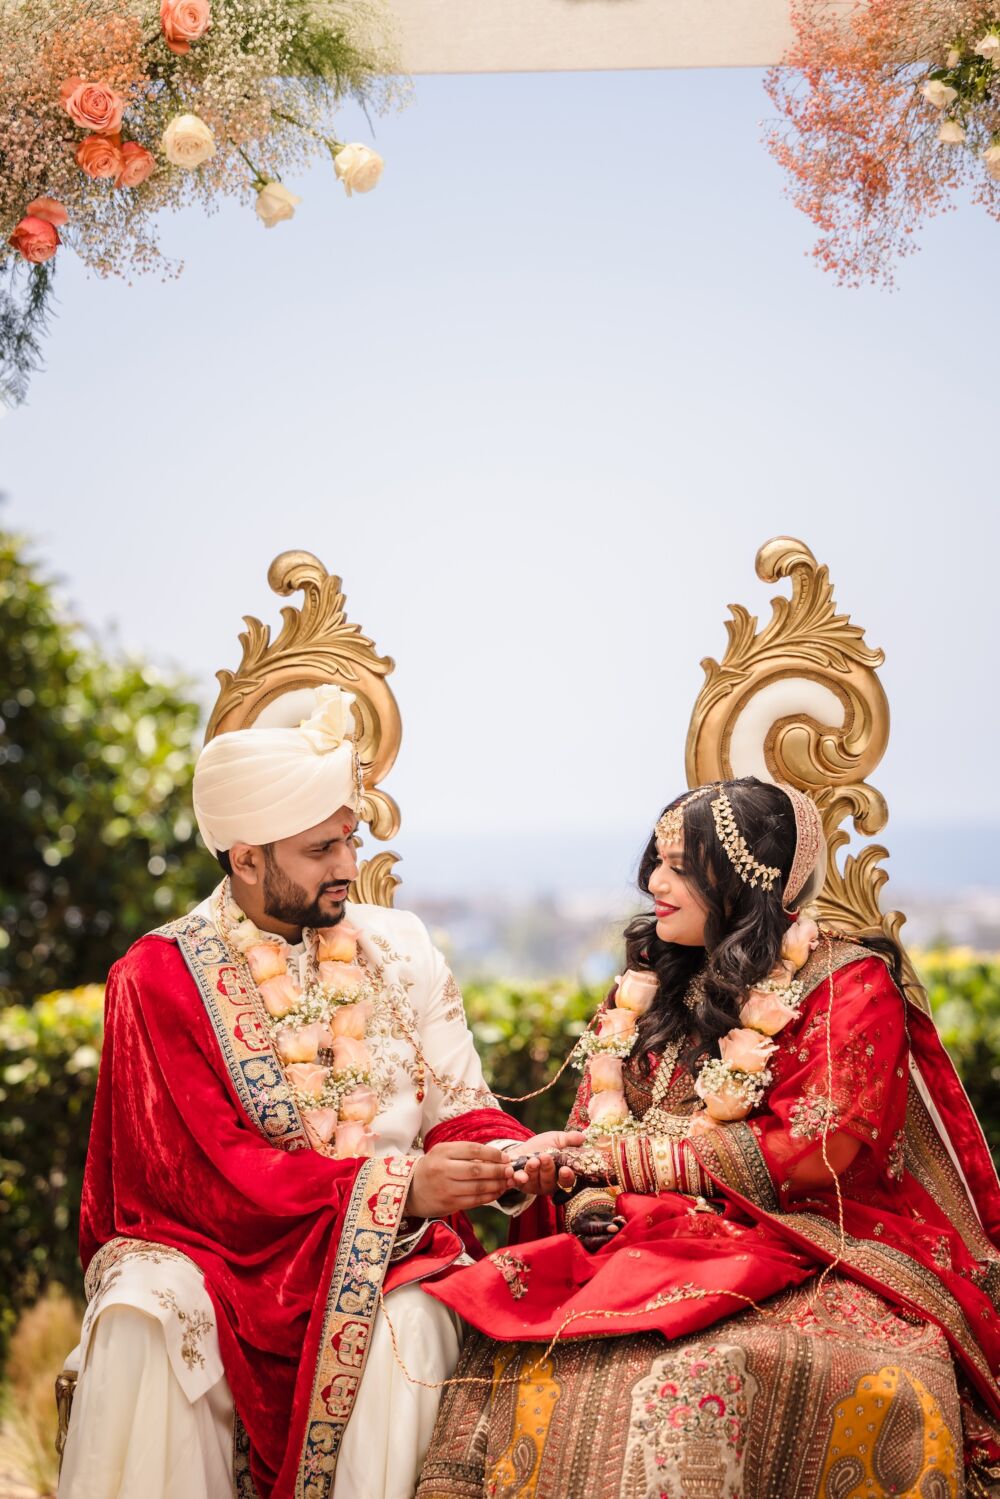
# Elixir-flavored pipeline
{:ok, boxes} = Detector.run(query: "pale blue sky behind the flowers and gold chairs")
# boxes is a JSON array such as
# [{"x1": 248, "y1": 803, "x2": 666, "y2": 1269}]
[{"x1": 0, "y1": 70, "x2": 1000, "y2": 887}]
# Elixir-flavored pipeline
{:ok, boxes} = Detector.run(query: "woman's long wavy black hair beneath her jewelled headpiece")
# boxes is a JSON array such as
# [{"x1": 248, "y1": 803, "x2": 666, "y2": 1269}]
[{"x1": 625, "y1": 775, "x2": 903, "y2": 1058}]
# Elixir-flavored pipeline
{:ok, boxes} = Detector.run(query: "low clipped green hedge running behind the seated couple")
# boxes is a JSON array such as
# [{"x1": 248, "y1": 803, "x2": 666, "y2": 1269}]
[{"x1": 0, "y1": 949, "x2": 1000, "y2": 1345}]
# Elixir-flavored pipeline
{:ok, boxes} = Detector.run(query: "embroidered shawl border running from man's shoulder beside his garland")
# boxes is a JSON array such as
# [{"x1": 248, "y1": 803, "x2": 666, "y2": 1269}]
[{"x1": 159, "y1": 914, "x2": 312, "y2": 1150}]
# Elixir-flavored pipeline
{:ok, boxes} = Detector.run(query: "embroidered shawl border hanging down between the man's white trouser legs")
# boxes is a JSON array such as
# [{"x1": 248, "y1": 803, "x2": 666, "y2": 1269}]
[{"x1": 295, "y1": 1156, "x2": 415, "y2": 1499}]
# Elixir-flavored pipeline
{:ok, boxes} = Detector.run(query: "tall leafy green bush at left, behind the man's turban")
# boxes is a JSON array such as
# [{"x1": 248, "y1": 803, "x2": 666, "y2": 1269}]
[{"x1": 0, "y1": 531, "x2": 214, "y2": 1003}]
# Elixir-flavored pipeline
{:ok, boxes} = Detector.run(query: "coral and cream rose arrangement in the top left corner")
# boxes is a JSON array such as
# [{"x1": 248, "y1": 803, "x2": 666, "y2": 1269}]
[{"x1": 0, "y1": 0, "x2": 400, "y2": 403}]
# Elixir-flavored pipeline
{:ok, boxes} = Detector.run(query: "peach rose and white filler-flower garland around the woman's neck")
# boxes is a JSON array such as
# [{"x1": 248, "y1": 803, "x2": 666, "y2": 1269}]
[{"x1": 574, "y1": 916, "x2": 820, "y2": 1142}]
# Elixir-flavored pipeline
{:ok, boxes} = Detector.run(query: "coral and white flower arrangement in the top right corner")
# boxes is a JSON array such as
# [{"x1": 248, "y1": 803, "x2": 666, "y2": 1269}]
[{"x1": 766, "y1": 0, "x2": 1000, "y2": 286}]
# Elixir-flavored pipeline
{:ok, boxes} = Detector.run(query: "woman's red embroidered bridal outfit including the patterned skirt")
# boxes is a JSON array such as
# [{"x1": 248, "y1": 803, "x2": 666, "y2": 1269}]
[{"x1": 418, "y1": 938, "x2": 1000, "y2": 1499}]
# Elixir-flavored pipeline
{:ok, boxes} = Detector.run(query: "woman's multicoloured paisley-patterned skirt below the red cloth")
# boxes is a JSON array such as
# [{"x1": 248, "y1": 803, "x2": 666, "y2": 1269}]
[{"x1": 417, "y1": 1276, "x2": 971, "y2": 1499}]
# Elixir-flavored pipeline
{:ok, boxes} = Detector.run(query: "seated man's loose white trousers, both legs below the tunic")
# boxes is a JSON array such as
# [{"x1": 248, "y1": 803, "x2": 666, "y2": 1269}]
[{"x1": 58, "y1": 1286, "x2": 462, "y2": 1499}]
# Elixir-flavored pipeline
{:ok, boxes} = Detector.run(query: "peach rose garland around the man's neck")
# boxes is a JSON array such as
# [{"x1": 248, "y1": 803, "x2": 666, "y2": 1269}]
[{"x1": 219, "y1": 901, "x2": 381, "y2": 1157}]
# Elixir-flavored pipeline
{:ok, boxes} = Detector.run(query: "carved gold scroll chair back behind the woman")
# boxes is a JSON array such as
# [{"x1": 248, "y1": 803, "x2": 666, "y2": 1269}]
[{"x1": 687, "y1": 537, "x2": 927, "y2": 1009}]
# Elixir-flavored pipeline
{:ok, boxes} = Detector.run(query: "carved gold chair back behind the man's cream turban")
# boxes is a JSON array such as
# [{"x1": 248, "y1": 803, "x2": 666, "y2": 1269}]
[{"x1": 205, "y1": 552, "x2": 402, "y2": 905}]
